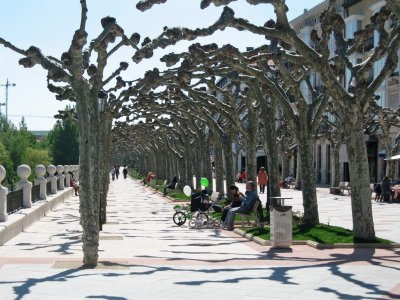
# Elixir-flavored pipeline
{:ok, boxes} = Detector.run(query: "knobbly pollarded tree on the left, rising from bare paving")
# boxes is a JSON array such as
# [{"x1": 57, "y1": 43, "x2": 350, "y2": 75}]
[{"x1": 0, "y1": 0, "x2": 181, "y2": 267}]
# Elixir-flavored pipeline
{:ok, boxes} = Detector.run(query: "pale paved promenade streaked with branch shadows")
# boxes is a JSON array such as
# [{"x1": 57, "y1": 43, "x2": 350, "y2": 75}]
[{"x1": 0, "y1": 179, "x2": 400, "y2": 300}]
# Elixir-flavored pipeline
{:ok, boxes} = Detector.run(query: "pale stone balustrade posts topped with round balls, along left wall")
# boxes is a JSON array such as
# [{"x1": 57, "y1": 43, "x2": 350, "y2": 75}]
[{"x1": 0, "y1": 165, "x2": 79, "y2": 222}]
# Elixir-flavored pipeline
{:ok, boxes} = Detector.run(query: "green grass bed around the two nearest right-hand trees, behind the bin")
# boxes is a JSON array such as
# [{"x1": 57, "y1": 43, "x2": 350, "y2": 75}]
[{"x1": 242, "y1": 224, "x2": 392, "y2": 244}]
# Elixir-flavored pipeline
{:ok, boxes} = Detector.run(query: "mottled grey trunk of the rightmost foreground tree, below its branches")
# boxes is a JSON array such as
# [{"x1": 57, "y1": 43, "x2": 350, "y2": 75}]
[{"x1": 345, "y1": 118, "x2": 375, "y2": 241}]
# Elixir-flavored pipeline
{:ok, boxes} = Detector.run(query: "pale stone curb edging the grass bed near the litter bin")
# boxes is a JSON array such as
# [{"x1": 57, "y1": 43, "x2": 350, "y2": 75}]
[{"x1": 233, "y1": 228, "x2": 400, "y2": 250}]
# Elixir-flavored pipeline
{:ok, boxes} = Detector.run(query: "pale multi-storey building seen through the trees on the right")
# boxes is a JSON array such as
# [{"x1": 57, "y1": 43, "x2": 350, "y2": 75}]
[{"x1": 291, "y1": 0, "x2": 400, "y2": 184}]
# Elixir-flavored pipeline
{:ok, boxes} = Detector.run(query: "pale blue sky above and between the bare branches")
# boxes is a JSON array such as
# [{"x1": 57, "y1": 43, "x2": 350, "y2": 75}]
[{"x1": 0, "y1": 0, "x2": 321, "y2": 130}]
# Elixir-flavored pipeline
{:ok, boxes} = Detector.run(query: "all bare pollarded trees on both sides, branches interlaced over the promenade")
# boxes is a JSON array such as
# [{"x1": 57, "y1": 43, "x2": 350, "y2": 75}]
[{"x1": 0, "y1": 0, "x2": 400, "y2": 266}]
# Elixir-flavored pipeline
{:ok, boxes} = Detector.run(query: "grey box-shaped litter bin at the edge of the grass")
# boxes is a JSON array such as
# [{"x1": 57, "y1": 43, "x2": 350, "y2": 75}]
[{"x1": 270, "y1": 206, "x2": 293, "y2": 248}]
